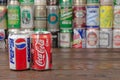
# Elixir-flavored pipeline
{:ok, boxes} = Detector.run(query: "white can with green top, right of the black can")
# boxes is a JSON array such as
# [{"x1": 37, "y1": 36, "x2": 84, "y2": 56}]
[{"x1": 59, "y1": 29, "x2": 72, "y2": 48}]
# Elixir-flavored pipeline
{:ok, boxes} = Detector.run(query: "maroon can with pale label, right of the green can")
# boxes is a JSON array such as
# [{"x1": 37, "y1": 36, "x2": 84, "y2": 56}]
[{"x1": 73, "y1": 5, "x2": 86, "y2": 28}]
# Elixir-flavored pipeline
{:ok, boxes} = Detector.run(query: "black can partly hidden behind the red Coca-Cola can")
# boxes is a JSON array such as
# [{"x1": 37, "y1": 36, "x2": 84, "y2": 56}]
[{"x1": 51, "y1": 31, "x2": 59, "y2": 48}]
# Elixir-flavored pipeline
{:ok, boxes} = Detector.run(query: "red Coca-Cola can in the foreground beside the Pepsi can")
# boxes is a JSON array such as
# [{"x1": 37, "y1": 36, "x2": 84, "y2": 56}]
[{"x1": 31, "y1": 31, "x2": 52, "y2": 70}]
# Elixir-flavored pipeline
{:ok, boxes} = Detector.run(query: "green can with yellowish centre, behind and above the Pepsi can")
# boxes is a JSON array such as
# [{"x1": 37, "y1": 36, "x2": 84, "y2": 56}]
[{"x1": 8, "y1": 5, "x2": 20, "y2": 28}]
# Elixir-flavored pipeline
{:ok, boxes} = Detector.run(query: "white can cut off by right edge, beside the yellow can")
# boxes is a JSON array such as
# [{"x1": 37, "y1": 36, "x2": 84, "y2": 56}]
[{"x1": 113, "y1": 5, "x2": 120, "y2": 28}]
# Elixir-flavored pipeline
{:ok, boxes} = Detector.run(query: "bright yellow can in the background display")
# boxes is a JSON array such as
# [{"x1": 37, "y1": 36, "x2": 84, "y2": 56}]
[{"x1": 100, "y1": 6, "x2": 113, "y2": 28}]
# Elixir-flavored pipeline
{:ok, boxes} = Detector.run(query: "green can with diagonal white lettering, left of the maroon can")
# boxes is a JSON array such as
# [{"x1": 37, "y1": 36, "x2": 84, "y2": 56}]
[{"x1": 59, "y1": 6, "x2": 73, "y2": 29}]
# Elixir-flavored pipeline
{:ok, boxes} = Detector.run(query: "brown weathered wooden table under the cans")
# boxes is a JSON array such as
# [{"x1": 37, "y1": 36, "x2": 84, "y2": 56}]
[{"x1": 0, "y1": 49, "x2": 120, "y2": 80}]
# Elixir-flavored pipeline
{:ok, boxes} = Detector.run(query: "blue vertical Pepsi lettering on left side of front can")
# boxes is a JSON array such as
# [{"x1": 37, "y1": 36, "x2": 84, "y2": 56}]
[{"x1": 9, "y1": 39, "x2": 15, "y2": 64}]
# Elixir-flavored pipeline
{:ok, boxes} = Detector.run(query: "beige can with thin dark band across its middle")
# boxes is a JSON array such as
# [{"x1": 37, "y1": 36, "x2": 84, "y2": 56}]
[{"x1": 34, "y1": 6, "x2": 47, "y2": 30}]
